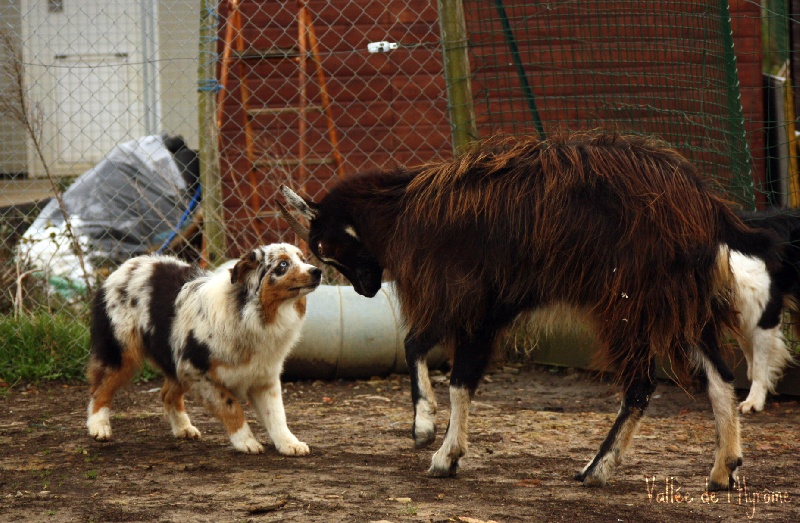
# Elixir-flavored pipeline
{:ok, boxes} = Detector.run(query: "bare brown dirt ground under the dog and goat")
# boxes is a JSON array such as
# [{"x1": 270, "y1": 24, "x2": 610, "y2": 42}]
[{"x1": 0, "y1": 365, "x2": 800, "y2": 522}]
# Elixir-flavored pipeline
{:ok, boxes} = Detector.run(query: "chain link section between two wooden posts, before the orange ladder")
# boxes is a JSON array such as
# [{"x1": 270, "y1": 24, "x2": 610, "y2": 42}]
[{"x1": 212, "y1": 0, "x2": 451, "y2": 252}]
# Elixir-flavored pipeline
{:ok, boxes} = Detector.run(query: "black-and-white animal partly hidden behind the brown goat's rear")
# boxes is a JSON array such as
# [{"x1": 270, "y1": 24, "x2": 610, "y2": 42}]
[{"x1": 731, "y1": 209, "x2": 800, "y2": 413}]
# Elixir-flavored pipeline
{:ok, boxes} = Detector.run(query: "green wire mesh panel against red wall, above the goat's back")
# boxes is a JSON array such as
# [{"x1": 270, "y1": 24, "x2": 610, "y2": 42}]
[{"x1": 466, "y1": 0, "x2": 752, "y2": 208}]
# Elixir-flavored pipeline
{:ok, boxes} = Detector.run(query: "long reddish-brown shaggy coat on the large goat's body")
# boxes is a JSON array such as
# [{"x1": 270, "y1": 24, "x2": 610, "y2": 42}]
[{"x1": 374, "y1": 134, "x2": 752, "y2": 379}]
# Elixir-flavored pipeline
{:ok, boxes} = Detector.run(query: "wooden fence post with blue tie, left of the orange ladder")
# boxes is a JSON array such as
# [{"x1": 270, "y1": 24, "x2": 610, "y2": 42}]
[{"x1": 197, "y1": 0, "x2": 227, "y2": 267}]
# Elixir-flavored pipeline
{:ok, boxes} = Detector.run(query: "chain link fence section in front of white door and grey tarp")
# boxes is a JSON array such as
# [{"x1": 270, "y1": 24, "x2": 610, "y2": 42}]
[{"x1": 0, "y1": 0, "x2": 199, "y2": 320}]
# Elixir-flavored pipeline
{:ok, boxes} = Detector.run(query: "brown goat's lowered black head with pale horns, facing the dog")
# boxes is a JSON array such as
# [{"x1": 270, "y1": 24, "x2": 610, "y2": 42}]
[{"x1": 278, "y1": 186, "x2": 383, "y2": 298}]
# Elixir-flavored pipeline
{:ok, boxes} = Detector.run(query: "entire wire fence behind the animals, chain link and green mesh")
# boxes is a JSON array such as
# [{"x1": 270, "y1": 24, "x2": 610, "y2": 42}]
[{"x1": 0, "y1": 0, "x2": 800, "y2": 368}]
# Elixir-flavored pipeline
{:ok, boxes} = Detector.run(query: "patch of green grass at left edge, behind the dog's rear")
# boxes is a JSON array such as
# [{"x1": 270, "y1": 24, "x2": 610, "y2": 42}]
[{"x1": 0, "y1": 313, "x2": 89, "y2": 385}]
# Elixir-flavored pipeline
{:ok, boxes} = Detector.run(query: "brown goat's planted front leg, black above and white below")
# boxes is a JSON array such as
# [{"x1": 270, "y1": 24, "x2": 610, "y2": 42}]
[{"x1": 428, "y1": 331, "x2": 495, "y2": 477}]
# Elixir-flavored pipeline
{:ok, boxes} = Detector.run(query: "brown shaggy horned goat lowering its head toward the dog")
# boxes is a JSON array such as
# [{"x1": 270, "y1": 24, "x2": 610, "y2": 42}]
[{"x1": 281, "y1": 133, "x2": 772, "y2": 489}]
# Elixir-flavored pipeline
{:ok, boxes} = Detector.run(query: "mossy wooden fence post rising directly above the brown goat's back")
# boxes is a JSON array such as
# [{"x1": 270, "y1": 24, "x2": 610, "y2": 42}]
[{"x1": 439, "y1": 0, "x2": 478, "y2": 155}]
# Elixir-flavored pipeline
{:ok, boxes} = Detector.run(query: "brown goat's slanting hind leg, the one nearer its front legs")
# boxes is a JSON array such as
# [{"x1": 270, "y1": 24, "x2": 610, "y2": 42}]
[{"x1": 575, "y1": 360, "x2": 656, "y2": 486}]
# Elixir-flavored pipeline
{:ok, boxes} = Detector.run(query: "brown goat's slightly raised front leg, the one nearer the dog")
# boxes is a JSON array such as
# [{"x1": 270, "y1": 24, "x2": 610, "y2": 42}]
[{"x1": 405, "y1": 329, "x2": 439, "y2": 448}]
